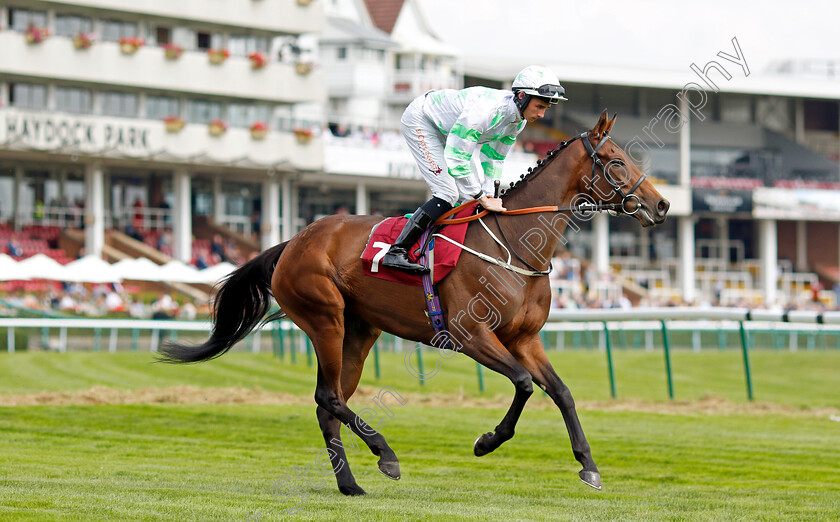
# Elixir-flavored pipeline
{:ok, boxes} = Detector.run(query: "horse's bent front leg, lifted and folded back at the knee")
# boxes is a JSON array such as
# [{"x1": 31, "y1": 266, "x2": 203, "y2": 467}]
[{"x1": 461, "y1": 330, "x2": 534, "y2": 457}]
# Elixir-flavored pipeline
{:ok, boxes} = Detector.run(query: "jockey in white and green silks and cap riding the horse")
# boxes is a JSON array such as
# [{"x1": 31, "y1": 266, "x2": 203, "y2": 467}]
[{"x1": 381, "y1": 66, "x2": 567, "y2": 273}]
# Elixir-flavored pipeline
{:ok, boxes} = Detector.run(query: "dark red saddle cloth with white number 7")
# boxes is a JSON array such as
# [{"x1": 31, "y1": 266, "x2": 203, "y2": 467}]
[{"x1": 362, "y1": 203, "x2": 478, "y2": 286}]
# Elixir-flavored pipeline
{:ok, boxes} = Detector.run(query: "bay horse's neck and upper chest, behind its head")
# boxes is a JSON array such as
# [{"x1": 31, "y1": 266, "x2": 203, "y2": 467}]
[{"x1": 500, "y1": 151, "x2": 583, "y2": 268}]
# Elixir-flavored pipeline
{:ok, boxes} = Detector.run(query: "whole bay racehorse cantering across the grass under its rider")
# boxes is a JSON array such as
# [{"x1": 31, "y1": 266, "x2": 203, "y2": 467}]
[{"x1": 162, "y1": 111, "x2": 669, "y2": 495}]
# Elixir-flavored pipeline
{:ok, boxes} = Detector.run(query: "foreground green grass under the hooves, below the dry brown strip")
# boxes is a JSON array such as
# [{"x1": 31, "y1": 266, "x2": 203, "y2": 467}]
[{"x1": 0, "y1": 404, "x2": 840, "y2": 520}]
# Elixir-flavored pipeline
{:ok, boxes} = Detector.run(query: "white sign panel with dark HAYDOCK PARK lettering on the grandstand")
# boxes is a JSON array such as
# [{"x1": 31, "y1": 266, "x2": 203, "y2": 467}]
[{"x1": 0, "y1": 109, "x2": 153, "y2": 155}]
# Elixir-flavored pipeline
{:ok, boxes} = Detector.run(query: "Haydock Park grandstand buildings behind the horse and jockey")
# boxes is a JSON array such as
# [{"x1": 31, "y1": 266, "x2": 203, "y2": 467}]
[{"x1": 0, "y1": 0, "x2": 840, "y2": 307}]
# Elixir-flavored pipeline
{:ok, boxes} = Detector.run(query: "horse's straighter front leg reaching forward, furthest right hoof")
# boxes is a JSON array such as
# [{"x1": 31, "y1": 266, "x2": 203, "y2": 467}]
[{"x1": 508, "y1": 334, "x2": 601, "y2": 489}]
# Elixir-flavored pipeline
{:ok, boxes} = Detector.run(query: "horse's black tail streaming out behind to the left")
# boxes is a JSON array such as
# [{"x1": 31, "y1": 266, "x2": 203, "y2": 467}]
[{"x1": 159, "y1": 241, "x2": 288, "y2": 363}]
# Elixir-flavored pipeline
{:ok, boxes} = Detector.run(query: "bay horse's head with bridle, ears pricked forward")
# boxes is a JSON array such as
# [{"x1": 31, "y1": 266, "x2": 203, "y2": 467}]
[{"x1": 578, "y1": 111, "x2": 671, "y2": 227}]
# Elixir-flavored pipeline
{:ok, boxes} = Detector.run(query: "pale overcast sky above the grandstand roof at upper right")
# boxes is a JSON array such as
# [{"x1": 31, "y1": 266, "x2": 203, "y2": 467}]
[{"x1": 420, "y1": 0, "x2": 840, "y2": 75}]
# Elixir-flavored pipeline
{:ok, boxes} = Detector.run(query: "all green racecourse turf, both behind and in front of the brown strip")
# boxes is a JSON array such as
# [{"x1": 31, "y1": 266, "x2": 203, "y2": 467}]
[{"x1": 0, "y1": 350, "x2": 840, "y2": 521}]
